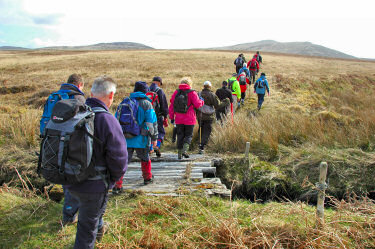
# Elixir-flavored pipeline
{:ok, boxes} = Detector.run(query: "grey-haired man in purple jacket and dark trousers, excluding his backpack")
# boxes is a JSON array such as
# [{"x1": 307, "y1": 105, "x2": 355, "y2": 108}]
[{"x1": 67, "y1": 76, "x2": 128, "y2": 249}]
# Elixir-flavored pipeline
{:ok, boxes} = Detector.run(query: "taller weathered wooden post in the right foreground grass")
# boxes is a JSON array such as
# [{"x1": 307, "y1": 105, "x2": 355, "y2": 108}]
[{"x1": 316, "y1": 162, "x2": 328, "y2": 226}]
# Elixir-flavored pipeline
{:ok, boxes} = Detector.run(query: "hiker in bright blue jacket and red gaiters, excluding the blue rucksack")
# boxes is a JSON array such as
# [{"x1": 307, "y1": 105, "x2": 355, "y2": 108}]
[{"x1": 112, "y1": 81, "x2": 158, "y2": 194}]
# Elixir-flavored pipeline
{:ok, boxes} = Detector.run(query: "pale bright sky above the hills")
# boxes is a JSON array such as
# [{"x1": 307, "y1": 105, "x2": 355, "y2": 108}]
[{"x1": 0, "y1": 0, "x2": 375, "y2": 58}]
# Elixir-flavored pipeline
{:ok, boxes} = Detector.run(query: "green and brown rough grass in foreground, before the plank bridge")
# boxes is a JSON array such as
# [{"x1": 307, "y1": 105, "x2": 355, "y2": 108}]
[{"x1": 0, "y1": 187, "x2": 375, "y2": 248}]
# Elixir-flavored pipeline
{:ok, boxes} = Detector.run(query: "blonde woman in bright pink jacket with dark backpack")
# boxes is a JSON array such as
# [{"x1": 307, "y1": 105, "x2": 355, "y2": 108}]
[{"x1": 169, "y1": 77, "x2": 204, "y2": 159}]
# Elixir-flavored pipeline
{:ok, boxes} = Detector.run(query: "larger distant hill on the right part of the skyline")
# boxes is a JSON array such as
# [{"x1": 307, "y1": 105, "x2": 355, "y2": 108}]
[{"x1": 209, "y1": 40, "x2": 356, "y2": 59}]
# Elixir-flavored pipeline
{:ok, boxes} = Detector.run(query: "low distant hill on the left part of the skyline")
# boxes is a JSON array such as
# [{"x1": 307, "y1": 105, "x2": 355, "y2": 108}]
[{"x1": 41, "y1": 42, "x2": 154, "y2": 50}]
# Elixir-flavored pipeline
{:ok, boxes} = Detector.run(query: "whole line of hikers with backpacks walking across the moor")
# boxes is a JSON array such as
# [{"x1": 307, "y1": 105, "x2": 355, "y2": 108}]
[{"x1": 38, "y1": 53, "x2": 269, "y2": 248}]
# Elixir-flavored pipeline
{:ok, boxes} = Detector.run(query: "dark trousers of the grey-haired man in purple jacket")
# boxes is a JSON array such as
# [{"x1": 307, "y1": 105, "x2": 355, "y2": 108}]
[{"x1": 70, "y1": 191, "x2": 108, "y2": 249}]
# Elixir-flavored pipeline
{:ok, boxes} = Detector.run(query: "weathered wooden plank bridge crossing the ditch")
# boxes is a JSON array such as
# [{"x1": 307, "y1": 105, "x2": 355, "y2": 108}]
[{"x1": 116, "y1": 152, "x2": 231, "y2": 198}]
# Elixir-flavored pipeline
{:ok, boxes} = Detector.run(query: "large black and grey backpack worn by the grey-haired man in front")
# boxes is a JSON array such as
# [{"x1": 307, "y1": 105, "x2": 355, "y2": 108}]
[{"x1": 37, "y1": 99, "x2": 109, "y2": 186}]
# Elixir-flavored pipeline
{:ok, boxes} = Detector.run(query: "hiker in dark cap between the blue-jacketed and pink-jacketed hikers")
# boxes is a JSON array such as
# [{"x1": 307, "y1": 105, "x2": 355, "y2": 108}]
[{"x1": 150, "y1": 76, "x2": 168, "y2": 157}]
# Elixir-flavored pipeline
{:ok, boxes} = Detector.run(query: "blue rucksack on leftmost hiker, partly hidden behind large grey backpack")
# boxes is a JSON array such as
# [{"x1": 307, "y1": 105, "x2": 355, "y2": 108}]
[{"x1": 40, "y1": 89, "x2": 74, "y2": 136}]
